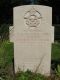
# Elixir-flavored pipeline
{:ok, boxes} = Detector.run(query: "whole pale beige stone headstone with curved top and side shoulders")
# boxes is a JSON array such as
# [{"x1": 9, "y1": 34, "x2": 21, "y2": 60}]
[{"x1": 10, "y1": 5, "x2": 54, "y2": 75}]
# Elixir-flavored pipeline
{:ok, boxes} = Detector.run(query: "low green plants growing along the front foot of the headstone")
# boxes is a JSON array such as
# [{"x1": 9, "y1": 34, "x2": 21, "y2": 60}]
[{"x1": 15, "y1": 70, "x2": 47, "y2": 80}]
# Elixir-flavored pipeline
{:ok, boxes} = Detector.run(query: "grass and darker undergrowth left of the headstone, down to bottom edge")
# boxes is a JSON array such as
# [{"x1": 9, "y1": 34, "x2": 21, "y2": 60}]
[{"x1": 0, "y1": 41, "x2": 14, "y2": 80}]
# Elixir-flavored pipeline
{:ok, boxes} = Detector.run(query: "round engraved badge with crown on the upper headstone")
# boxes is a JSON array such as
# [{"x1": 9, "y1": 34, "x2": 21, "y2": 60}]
[{"x1": 24, "y1": 7, "x2": 42, "y2": 27}]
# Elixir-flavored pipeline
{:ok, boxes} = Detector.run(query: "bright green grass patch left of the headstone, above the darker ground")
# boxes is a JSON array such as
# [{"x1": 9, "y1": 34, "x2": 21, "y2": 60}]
[{"x1": 0, "y1": 41, "x2": 14, "y2": 67}]
